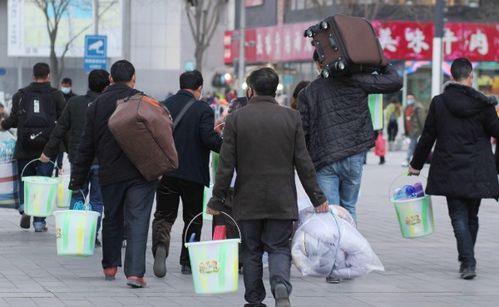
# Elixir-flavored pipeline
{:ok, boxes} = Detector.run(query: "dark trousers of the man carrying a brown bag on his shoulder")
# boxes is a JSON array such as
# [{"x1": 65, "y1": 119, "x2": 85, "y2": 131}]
[{"x1": 101, "y1": 179, "x2": 158, "y2": 277}]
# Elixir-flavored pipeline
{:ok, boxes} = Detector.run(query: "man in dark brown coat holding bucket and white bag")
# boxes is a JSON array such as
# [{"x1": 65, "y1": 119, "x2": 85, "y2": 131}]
[{"x1": 208, "y1": 68, "x2": 329, "y2": 307}]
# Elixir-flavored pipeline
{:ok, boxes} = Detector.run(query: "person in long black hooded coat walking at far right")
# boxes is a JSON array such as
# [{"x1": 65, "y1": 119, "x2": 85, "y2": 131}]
[{"x1": 409, "y1": 58, "x2": 499, "y2": 279}]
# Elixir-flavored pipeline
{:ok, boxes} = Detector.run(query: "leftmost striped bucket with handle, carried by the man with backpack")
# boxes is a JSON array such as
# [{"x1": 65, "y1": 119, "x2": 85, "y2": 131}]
[{"x1": 21, "y1": 159, "x2": 59, "y2": 217}]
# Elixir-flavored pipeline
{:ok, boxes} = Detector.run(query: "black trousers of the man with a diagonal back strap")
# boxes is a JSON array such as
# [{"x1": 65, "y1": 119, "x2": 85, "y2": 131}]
[{"x1": 152, "y1": 176, "x2": 204, "y2": 265}]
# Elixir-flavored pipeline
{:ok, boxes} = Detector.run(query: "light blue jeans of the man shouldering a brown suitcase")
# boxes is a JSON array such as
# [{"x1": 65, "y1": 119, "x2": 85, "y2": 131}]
[{"x1": 317, "y1": 152, "x2": 364, "y2": 220}]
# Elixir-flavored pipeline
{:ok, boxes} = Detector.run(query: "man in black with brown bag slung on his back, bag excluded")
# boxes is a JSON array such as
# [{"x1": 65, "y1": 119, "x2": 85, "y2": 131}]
[{"x1": 70, "y1": 60, "x2": 158, "y2": 288}]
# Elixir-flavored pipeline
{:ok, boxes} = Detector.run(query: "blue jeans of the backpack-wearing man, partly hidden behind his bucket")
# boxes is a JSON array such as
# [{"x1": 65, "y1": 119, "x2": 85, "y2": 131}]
[{"x1": 17, "y1": 160, "x2": 54, "y2": 227}]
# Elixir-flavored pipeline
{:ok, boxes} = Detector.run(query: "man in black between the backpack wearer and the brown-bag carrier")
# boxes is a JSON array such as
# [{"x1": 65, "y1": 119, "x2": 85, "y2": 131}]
[{"x1": 40, "y1": 69, "x2": 109, "y2": 246}]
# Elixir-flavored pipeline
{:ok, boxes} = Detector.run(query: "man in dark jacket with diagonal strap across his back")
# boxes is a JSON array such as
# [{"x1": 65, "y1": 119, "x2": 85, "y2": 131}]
[{"x1": 152, "y1": 70, "x2": 222, "y2": 277}]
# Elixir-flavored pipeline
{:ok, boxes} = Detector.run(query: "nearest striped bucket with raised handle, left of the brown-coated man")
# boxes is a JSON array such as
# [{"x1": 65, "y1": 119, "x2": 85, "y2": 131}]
[{"x1": 184, "y1": 212, "x2": 241, "y2": 294}]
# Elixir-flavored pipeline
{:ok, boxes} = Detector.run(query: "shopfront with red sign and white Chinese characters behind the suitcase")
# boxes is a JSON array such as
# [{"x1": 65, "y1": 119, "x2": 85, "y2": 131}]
[{"x1": 224, "y1": 0, "x2": 499, "y2": 103}]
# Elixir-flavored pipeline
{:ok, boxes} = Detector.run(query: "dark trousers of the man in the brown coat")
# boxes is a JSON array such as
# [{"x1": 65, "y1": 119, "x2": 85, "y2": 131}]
[{"x1": 238, "y1": 219, "x2": 293, "y2": 306}]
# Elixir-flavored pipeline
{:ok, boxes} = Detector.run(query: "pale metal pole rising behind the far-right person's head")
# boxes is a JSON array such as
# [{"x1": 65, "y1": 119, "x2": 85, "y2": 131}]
[{"x1": 431, "y1": 0, "x2": 445, "y2": 97}]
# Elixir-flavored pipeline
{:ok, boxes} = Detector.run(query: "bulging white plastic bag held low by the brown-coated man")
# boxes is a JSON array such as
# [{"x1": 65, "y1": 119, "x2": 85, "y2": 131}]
[{"x1": 291, "y1": 206, "x2": 384, "y2": 279}]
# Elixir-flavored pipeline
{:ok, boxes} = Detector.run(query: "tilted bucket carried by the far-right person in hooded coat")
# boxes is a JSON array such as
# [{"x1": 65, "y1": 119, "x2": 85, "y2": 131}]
[{"x1": 392, "y1": 195, "x2": 434, "y2": 239}]
